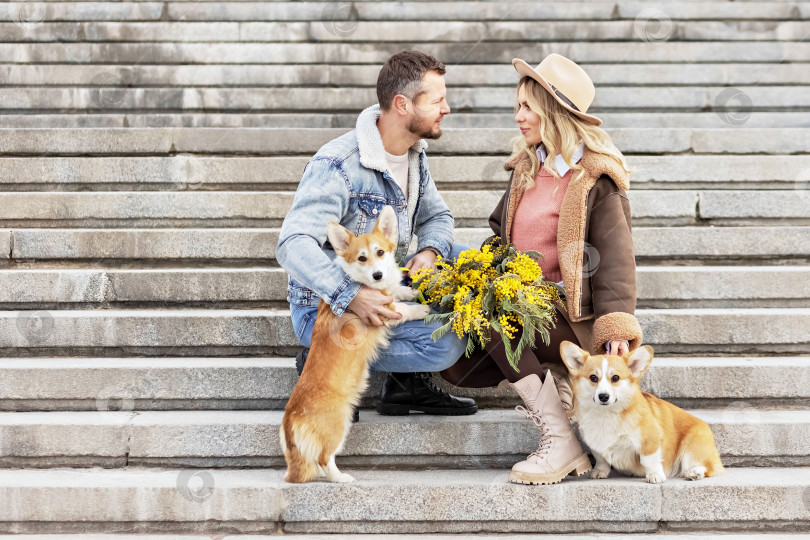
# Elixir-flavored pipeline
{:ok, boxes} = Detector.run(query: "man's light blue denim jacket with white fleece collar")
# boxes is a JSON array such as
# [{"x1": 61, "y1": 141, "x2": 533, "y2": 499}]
[{"x1": 276, "y1": 105, "x2": 454, "y2": 315}]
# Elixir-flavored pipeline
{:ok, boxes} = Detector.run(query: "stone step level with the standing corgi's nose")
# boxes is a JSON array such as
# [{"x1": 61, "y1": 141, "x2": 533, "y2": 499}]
[{"x1": 0, "y1": 265, "x2": 810, "y2": 310}]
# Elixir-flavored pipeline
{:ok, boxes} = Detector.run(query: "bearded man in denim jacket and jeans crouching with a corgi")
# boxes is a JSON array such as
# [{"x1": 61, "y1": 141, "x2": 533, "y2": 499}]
[{"x1": 276, "y1": 51, "x2": 478, "y2": 421}]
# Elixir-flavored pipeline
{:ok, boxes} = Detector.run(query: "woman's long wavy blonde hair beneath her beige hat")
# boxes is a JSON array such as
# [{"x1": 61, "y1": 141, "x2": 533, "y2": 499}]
[{"x1": 509, "y1": 76, "x2": 633, "y2": 190}]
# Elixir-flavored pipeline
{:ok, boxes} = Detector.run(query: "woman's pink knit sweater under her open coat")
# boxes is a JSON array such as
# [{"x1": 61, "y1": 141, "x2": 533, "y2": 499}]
[{"x1": 512, "y1": 166, "x2": 575, "y2": 282}]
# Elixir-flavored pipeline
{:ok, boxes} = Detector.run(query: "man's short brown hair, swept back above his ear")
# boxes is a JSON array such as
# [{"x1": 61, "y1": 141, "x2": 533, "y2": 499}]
[{"x1": 377, "y1": 51, "x2": 446, "y2": 111}]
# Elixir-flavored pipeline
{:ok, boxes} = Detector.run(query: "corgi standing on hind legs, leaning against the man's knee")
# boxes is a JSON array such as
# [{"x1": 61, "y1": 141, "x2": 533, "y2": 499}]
[{"x1": 279, "y1": 206, "x2": 430, "y2": 483}]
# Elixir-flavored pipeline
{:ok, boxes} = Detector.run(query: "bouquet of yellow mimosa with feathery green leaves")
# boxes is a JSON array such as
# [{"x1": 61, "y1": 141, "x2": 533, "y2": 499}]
[{"x1": 412, "y1": 244, "x2": 564, "y2": 371}]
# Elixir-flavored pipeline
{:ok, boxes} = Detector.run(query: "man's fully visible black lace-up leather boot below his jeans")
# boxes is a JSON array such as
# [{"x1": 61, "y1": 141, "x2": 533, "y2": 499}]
[{"x1": 377, "y1": 373, "x2": 478, "y2": 416}]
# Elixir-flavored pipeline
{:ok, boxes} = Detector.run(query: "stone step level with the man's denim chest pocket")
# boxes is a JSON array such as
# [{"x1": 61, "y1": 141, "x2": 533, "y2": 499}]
[{"x1": 0, "y1": 189, "x2": 810, "y2": 228}]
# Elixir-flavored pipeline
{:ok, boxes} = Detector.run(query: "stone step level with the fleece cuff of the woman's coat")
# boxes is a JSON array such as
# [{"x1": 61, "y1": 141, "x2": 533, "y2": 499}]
[{"x1": 0, "y1": 308, "x2": 810, "y2": 357}]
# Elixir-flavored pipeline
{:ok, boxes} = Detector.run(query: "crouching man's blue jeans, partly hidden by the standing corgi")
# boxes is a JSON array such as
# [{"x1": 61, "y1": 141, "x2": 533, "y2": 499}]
[{"x1": 290, "y1": 244, "x2": 469, "y2": 373}]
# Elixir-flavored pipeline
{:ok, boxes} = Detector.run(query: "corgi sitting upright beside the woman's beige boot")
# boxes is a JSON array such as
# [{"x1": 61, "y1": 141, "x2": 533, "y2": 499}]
[{"x1": 560, "y1": 341, "x2": 725, "y2": 484}]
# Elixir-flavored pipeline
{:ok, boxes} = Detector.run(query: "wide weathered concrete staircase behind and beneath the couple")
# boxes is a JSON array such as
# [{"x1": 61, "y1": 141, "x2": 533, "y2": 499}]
[{"x1": 0, "y1": 0, "x2": 810, "y2": 539}]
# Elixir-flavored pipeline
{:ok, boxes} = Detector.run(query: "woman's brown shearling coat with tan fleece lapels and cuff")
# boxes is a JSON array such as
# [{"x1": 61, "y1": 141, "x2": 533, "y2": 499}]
[{"x1": 443, "y1": 143, "x2": 643, "y2": 387}]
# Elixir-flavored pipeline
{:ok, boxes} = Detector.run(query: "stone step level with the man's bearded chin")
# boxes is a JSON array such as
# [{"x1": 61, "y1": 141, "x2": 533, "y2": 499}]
[{"x1": 0, "y1": 129, "x2": 810, "y2": 159}]
